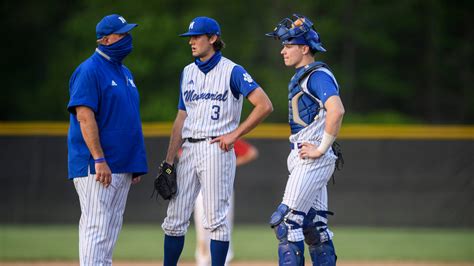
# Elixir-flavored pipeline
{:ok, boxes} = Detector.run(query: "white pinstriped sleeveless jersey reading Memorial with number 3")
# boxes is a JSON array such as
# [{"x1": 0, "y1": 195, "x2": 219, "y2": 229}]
[{"x1": 180, "y1": 57, "x2": 243, "y2": 138}]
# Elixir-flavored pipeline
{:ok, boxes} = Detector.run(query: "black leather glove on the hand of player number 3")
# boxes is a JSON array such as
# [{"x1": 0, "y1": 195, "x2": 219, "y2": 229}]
[{"x1": 152, "y1": 161, "x2": 178, "y2": 200}]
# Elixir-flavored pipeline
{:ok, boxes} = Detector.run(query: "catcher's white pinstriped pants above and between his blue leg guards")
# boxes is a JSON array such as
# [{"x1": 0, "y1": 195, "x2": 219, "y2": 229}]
[{"x1": 282, "y1": 149, "x2": 337, "y2": 242}]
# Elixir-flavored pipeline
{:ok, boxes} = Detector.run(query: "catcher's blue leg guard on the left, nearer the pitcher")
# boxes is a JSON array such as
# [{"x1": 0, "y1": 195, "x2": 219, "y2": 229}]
[{"x1": 270, "y1": 204, "x2": 304, "y2": 266}]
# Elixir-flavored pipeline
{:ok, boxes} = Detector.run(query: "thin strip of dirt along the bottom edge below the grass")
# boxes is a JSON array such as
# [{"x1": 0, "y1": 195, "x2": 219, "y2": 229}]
[{"x1": 0, "y1": 261, "x2": 474, "y2": 266}]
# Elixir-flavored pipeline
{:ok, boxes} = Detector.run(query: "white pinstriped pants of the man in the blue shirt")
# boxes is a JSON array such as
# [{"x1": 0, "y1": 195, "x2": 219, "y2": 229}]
[{"x1": 74, "y1": 173, "x2": 132, "y2": 266}]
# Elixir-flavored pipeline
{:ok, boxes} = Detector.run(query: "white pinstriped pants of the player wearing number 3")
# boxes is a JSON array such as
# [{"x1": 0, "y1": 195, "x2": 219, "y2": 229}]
[{"x1": 161, "y1": 139, "x2": 236, "y2": 241}]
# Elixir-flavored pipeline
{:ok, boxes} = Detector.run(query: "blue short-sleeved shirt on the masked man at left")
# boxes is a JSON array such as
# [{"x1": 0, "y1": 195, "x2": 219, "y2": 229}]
[{"x1": 67, "y1": 52, "x2": 148, "y2": 179}]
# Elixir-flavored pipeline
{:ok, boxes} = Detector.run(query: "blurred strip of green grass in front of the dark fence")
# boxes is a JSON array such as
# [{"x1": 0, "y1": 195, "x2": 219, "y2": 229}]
[{"x1": 0, "y1": 225, "x2": 474, "y2": 262}]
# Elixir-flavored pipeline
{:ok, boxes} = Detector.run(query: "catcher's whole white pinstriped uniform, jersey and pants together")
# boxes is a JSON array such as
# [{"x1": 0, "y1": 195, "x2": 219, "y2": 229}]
[{"x1": 282, "y1": 67, "x2": 338, "y2": 242}]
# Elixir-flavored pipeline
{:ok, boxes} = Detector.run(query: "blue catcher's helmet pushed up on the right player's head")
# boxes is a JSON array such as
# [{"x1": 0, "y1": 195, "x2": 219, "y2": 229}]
[{"x1": 265, "y1": 14, "x2": 326, "y2": 52}]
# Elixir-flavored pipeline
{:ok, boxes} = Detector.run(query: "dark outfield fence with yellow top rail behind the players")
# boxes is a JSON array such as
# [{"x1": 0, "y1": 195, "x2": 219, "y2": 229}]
[{"x1": 0, "y1": 122, "x2": 474, "y2": 227}]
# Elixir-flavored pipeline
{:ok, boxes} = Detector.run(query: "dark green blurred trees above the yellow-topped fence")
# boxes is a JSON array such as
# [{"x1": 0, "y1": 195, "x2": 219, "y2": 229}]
[{"x1": 0, "y1": 0, "x2": 474, "y2": 124}]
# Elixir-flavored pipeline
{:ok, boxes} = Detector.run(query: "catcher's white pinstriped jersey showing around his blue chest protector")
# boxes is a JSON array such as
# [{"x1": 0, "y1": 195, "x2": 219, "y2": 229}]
[{"x1": 289, "y1": 67, "x2": 339, "y2": 143}]
